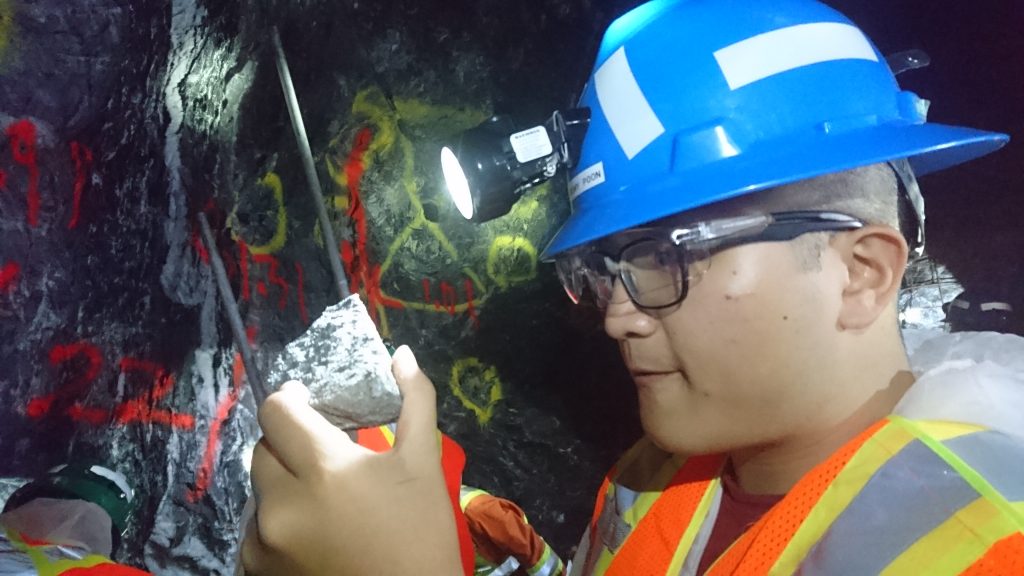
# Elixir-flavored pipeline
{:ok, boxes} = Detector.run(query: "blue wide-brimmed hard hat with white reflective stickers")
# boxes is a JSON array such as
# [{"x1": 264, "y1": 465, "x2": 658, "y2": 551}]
[{"x1": 544, "y1": 0, "x2": 1009, "y2": 258}]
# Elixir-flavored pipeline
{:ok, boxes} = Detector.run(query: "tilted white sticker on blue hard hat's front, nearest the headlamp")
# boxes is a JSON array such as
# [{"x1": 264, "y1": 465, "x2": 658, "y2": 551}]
[{"x1": 594, "y1": 47, "x2": 665, "y2": 160}]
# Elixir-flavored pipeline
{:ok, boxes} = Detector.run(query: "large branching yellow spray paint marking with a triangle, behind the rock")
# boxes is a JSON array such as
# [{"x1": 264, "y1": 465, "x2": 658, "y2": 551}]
[{"x1": 327, "y1": 87, "x2": 488, "y2": 337}]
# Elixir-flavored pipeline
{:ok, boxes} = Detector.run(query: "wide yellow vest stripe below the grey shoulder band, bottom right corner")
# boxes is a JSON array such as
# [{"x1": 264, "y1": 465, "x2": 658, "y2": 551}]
[{"x1": 882, "y1": 497, "x2": 1019, "y2": 575}]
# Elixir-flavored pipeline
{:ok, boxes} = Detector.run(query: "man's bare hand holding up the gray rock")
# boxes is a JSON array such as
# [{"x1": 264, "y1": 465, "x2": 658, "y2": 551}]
[{"x1": 242, "y1": 346, "x2": 461, "y2": 576}]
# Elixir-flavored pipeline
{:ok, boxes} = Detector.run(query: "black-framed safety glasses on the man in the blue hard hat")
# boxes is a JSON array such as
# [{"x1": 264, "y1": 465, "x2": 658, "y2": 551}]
[{"x1": 556, "y1": 210, "x2": 865, "y2": 310}]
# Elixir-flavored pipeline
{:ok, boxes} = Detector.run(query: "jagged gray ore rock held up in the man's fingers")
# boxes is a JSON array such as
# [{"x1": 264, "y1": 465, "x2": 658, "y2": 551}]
[{"x1": 268, "y1": 294, "x2": 401, "y2": 429}]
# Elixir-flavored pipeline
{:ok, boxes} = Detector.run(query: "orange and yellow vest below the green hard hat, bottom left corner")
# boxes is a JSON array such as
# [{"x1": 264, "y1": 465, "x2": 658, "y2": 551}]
[{"x1": 0, "y1": 529, "x2": 150, "y2": 576}]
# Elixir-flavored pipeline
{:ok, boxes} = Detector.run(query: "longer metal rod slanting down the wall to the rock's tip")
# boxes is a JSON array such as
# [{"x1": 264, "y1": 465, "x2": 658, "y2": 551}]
[{"x1": 272, "y1": 27, "x2": 349, "y2": 299}]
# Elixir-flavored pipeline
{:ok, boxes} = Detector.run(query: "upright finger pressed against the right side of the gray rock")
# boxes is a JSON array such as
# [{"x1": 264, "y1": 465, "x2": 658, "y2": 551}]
[{"x1": 391, "y1": 345, "x2": 438, "y2": 462}]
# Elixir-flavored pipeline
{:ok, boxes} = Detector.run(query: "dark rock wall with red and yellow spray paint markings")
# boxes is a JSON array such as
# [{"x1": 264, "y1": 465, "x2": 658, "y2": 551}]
[{"x1": 0, "y1": 0, "x2": 1024, "y2": 574}]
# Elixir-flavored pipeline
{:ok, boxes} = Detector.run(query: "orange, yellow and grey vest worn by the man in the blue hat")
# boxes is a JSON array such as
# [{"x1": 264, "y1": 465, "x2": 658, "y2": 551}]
[{"x1": 583, "y1": 416, "x2": 1024, "y2": 576}]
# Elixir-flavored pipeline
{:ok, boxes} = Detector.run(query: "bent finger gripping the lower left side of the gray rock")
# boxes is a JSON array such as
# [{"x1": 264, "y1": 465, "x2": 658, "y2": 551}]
[{"x1": 258, "y1": 382, "x2": 351, "y2": 477}]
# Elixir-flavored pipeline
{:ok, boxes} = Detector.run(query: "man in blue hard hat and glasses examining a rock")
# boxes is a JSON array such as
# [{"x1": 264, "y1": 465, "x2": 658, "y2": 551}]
[{"x1": 243, "y1": 0, "x2": 1024, "y2": 575}]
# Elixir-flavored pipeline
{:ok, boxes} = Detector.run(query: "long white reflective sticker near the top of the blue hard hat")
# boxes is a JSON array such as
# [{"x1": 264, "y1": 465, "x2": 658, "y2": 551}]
[{"x1": 715, "y1": 22, "x2": 879, "y2": 90}]
